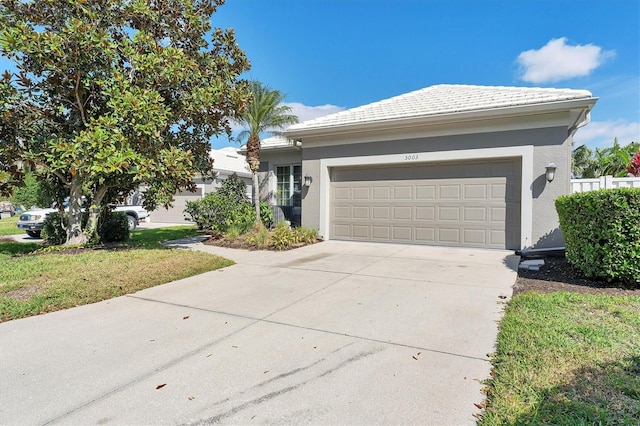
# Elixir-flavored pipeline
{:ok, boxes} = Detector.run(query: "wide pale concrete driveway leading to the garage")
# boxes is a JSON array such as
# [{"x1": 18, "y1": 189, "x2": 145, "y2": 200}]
[{"x1": 0, "y1": 241, "x2": 517, "y2": 425}]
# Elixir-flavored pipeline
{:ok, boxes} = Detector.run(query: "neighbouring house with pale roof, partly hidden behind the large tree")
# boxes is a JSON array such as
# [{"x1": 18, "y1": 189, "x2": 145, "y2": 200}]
[{"x1": 151, "y1": 147, "x2": 251, "y2": 223}]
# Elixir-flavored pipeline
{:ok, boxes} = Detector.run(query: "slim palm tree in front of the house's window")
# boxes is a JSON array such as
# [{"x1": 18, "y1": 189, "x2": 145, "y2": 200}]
[{"x1": 238, "y1": 80, "x2": 298, "y2": 222}]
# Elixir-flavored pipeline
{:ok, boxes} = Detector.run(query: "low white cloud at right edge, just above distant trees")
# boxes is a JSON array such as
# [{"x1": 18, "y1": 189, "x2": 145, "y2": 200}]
[{"x1": 573, "y1": 120, "x2": 640, "y2": 148}]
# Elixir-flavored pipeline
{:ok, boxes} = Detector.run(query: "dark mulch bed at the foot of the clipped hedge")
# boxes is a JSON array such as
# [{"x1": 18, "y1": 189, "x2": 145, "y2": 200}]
[{"x1": 513, "y1": 255, "x2": 640, "y2": 297}]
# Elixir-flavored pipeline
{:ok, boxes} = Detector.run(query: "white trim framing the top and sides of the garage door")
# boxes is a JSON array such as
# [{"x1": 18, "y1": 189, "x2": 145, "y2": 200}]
[{"x1": 318, "y1": 145, "x2": 533, "y2": 247}]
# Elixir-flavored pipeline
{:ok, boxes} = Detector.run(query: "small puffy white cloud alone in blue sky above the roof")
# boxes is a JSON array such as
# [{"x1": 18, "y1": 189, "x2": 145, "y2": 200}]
[{"x1": 518, "y1": 37, "x2": 615, "y2": 83}]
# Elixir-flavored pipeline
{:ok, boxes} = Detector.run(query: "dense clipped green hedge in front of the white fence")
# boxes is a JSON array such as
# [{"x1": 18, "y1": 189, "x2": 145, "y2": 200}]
[{"x1": 556, "y1": 188, "x2": 640, "y2": 288}]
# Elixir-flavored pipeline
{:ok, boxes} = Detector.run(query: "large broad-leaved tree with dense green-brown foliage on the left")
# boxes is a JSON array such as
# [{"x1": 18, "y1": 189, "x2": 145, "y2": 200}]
[{"x1": 0, "y1": 0, "x2": 249, "y2": 243}]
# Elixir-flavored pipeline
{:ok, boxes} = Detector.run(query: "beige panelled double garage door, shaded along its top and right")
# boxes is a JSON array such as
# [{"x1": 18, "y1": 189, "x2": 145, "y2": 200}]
[{"x1": 330, "y1": 159, "x2": 521, "y2": 249}]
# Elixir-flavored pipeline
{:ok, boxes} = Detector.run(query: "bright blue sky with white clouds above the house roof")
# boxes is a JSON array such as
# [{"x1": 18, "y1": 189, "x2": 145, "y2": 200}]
[{"x1": 212, "y1": 0, "x2": 640, "y2": 148}]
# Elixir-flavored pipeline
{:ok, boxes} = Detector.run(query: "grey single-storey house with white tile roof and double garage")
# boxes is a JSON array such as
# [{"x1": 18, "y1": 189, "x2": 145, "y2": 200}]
[{"x1": 261, "y1": 85, "x2": 597, "y2": 249}]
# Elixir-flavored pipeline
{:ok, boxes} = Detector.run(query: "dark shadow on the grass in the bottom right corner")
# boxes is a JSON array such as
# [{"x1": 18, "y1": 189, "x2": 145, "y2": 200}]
[{"x1": 514, "y1": 355, "x2": 640, "y2": 425}]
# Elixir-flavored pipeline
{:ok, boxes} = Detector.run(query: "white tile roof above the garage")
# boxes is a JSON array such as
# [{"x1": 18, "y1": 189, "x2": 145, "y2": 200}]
[{"x1": 287, "y1": 84, "x2": 592, "y2": 132}]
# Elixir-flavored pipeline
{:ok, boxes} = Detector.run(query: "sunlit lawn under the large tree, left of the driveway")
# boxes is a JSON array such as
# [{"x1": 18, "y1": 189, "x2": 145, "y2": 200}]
[{"x1": 0, "y1": 225, "x2": 233, "y2": 321}]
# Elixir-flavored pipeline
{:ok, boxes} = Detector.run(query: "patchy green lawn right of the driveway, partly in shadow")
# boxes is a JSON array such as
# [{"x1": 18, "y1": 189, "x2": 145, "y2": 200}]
[{"x1": 479, "y1": 292, "x2": 640, "y2": 426}]
